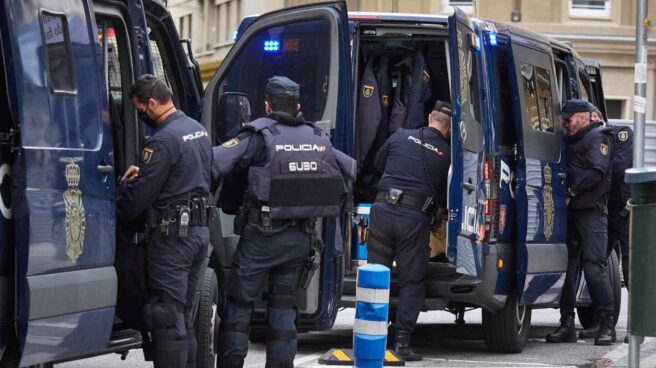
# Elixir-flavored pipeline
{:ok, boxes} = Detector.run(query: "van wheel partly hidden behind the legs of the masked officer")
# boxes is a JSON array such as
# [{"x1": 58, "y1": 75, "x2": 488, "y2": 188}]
[{"x1": 194, "y1": 267, "x2": 219, "y2": 368}]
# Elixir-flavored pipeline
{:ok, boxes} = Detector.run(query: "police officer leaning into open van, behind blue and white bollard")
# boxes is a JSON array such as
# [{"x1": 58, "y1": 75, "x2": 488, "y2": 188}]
[{"x1": 367, "y1": 101, "x2": 451, "y2": 361}]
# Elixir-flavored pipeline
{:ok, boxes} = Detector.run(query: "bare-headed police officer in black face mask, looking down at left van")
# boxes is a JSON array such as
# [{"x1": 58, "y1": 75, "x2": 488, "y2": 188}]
[{"x1": 117, "y1": 74, "x2": 212, "y2": 368}]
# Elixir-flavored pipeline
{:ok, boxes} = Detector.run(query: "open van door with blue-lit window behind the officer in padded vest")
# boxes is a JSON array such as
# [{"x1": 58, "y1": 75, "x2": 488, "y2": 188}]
[{"x1": 201, "y1": 2, "x2": 353, "y2": 330}]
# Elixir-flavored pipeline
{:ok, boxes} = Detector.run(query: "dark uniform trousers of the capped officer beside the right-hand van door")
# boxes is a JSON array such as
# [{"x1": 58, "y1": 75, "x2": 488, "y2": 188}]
[{"x1": 560, "y1": 207, "x2": 613, "y2": 313}]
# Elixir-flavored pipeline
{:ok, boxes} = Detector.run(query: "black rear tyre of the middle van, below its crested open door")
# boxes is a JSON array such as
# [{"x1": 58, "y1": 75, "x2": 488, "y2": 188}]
[{"x1": 483, "y1": 295, "x2": 531, "y2": 353}]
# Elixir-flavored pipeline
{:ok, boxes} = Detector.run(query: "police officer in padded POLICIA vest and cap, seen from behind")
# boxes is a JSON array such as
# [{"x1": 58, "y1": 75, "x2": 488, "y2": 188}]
[{"x1": 213, "y1": 76, "x2": 355, "y2": 368}]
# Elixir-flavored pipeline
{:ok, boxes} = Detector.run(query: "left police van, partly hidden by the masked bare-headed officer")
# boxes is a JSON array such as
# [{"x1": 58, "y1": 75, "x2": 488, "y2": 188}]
[{"x1": 0, "y1": 0, "x2": 218, "y2": 368}]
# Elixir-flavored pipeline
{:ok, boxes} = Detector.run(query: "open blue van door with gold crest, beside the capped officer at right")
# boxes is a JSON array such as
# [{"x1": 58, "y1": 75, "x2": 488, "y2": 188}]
[{"x1": 510, "y1": 34, "x2": 567, "y2": 305}]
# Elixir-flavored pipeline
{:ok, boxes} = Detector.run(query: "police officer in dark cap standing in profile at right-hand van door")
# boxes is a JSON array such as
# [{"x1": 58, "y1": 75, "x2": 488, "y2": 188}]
[{"x1": 547, "y1": 100, "x2": 616, "y2": 345}]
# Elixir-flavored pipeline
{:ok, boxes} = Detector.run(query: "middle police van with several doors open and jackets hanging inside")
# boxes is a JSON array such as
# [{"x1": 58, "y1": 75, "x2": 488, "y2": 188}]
[{"x1": 209, "y1": 2, "x2": 620, "y2": 352}]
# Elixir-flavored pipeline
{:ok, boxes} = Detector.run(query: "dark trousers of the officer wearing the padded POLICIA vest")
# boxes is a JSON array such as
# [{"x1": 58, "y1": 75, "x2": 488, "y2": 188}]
[{"x1": 219, "y1": 225, "x2": 310, "y2": 367}]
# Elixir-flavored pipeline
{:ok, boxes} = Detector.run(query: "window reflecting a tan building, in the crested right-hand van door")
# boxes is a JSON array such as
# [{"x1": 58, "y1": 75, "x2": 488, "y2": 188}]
[{"x1": 521, "y1": 63, "x2": 554, "y2": 133}]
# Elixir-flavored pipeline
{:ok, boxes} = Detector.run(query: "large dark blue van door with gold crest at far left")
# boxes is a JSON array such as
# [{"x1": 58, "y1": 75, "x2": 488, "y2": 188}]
[{"x1": 0, "y1": 0, "x2": 117, "y2": 366}]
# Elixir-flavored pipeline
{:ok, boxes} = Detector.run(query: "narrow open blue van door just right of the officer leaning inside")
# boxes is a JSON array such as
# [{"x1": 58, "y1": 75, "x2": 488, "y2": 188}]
[{"x1": 447, "y1": 8, "x2": 485, "y2": 276}]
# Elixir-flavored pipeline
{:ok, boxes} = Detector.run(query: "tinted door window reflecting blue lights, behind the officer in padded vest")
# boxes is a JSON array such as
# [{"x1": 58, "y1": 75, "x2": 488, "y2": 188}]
[{"x1": 215, "y1": 19, "x2": 332, "y2": 142}]
